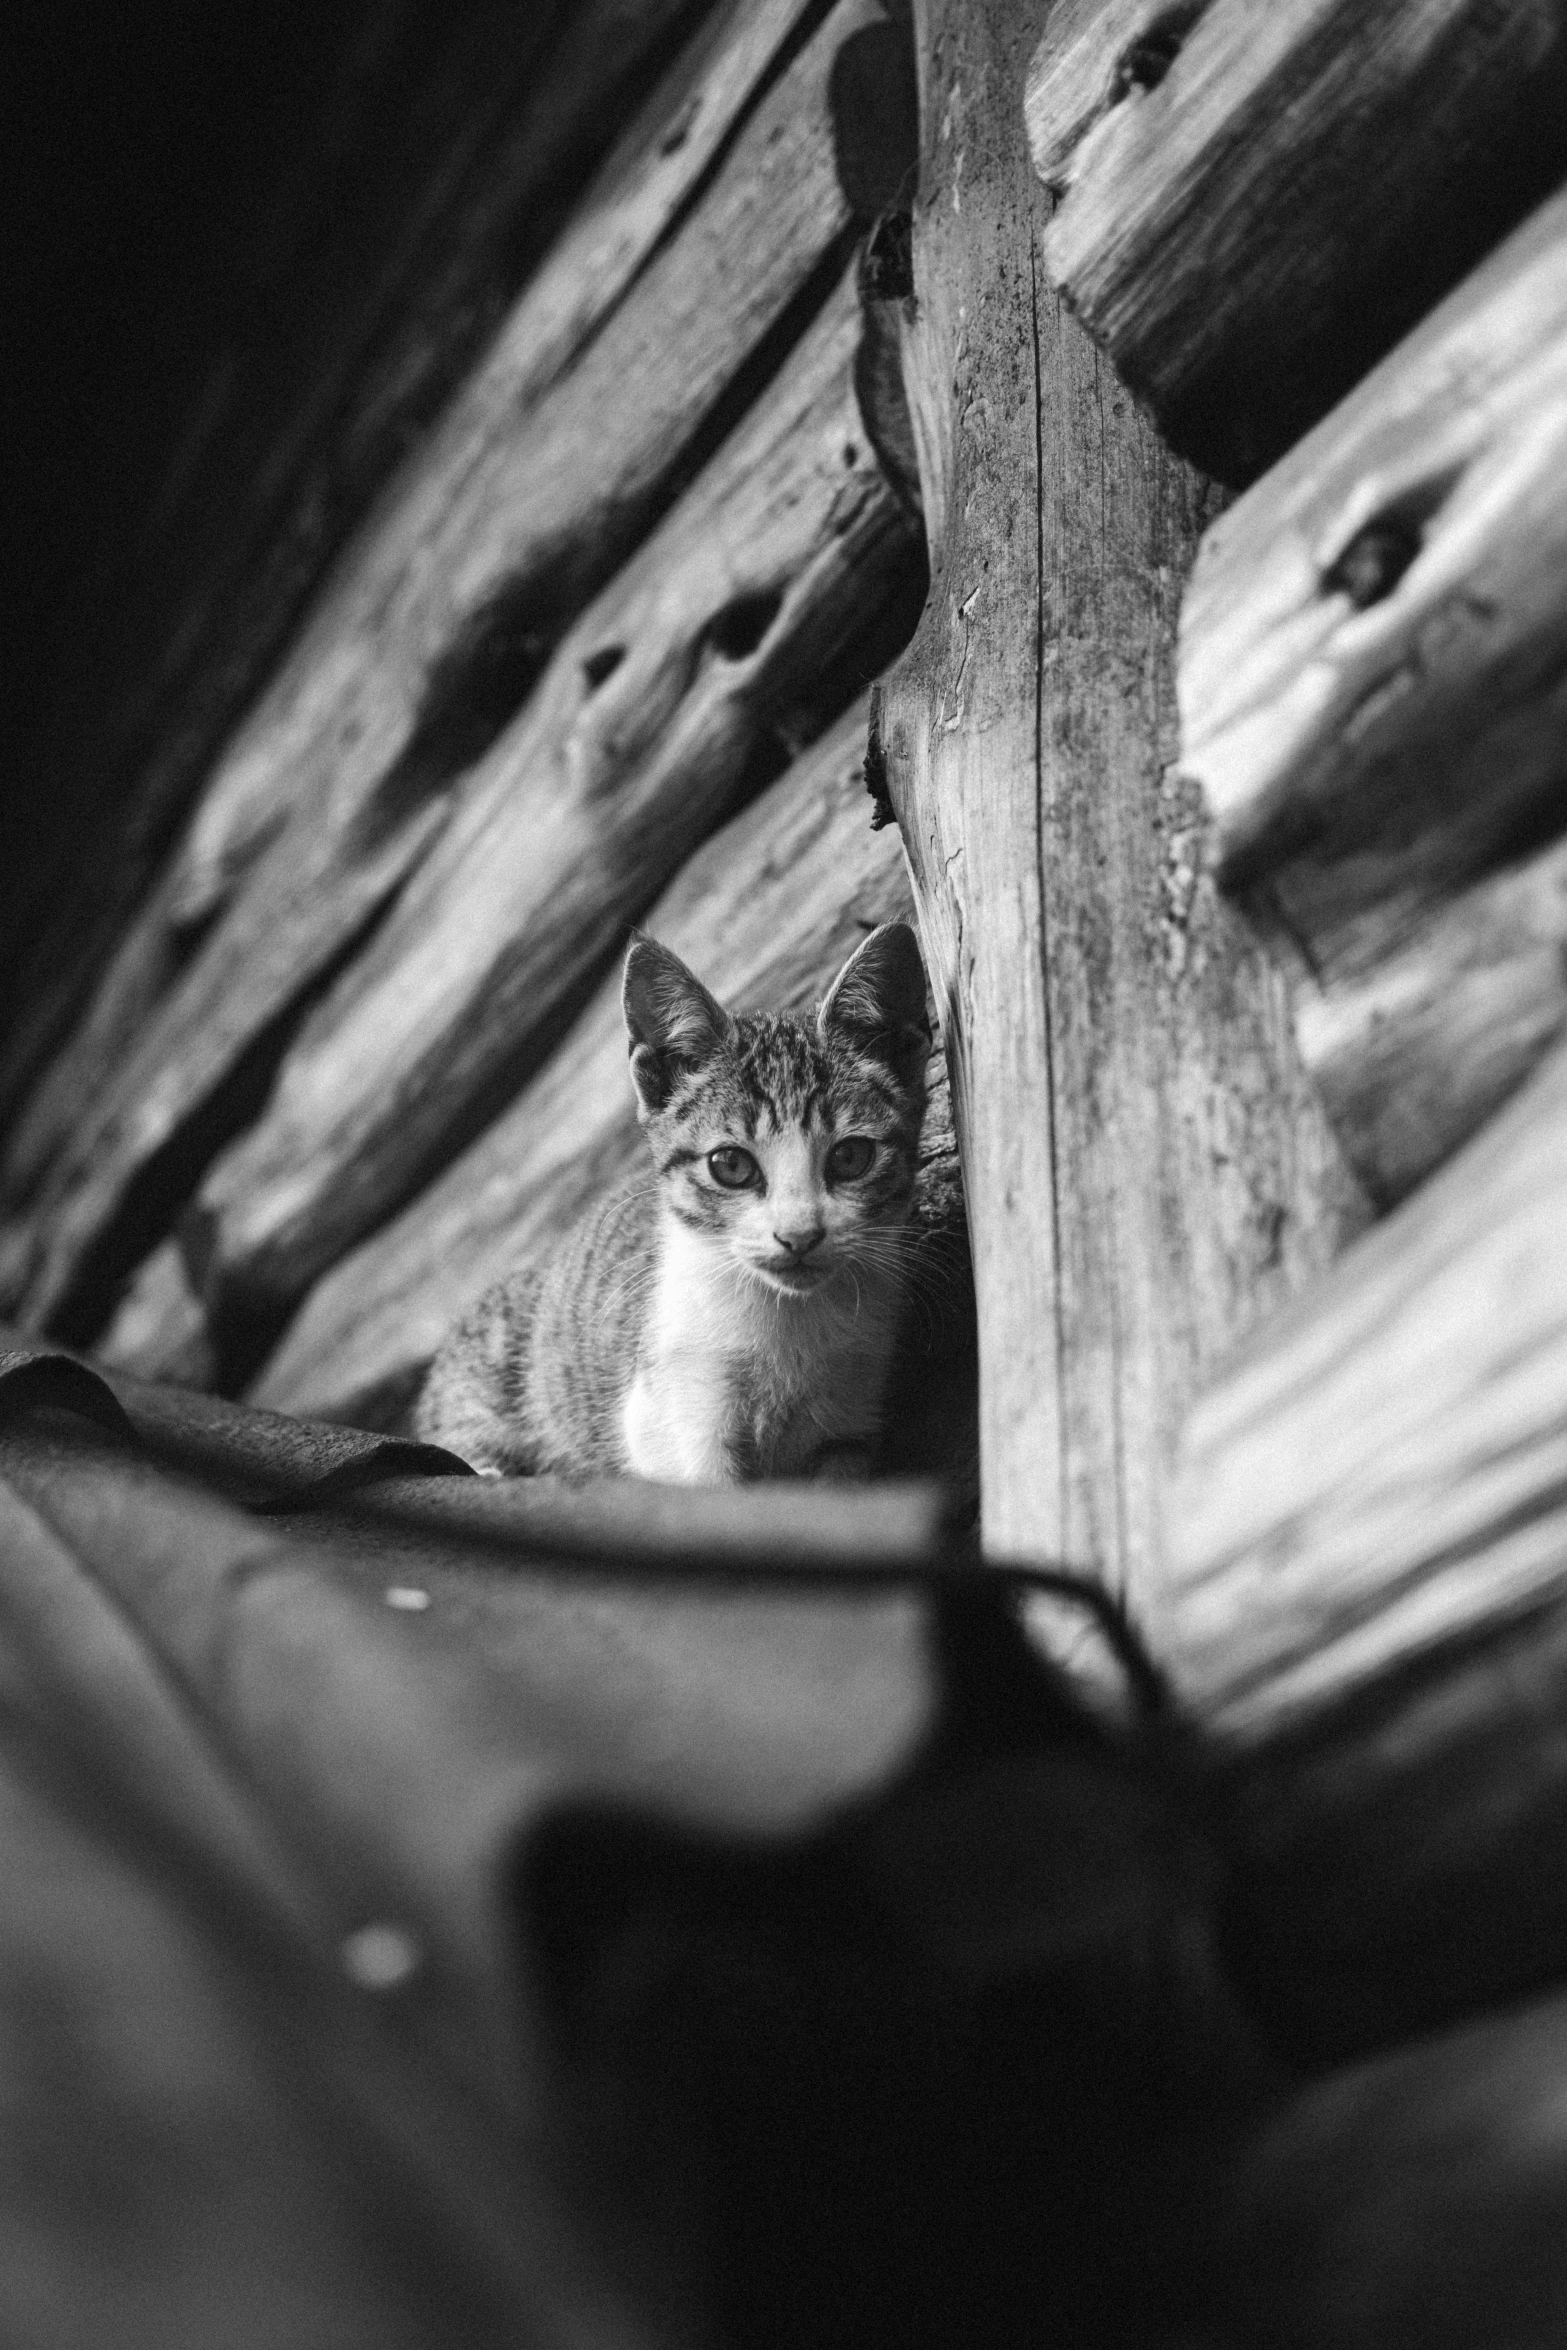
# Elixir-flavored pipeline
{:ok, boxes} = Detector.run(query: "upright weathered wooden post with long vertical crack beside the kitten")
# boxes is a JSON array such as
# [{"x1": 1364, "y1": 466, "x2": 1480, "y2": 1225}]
[{"x1": 879, "y1": 0, "x2": 1353, "y2": 1610}]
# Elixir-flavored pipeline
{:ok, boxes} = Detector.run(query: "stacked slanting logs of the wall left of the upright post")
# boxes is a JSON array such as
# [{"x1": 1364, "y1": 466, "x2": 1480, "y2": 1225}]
[{"x1": 0, "y1": 0, "x2": 923, "y2": 1412}]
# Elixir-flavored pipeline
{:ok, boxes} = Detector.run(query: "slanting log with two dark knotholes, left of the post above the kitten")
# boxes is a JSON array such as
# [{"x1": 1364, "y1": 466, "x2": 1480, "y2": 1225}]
[{"x1": 188, "y1": 282, "x2": 923, "y2": 1321}]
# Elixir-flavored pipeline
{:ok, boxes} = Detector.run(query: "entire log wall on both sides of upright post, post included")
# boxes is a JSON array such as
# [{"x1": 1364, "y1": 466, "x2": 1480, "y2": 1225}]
[{"x1": 0, "y1": 0, "x2": 1567, "y2": 2321}]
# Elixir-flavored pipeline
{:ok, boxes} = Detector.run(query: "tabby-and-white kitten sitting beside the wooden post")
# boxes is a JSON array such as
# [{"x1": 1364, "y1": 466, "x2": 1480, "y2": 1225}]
[{"x1": 416, "y1": 921, "x2": 930, "y2": 1485}]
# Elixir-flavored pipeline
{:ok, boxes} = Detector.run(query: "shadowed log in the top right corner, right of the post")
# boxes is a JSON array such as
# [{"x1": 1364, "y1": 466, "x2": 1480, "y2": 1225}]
[{"x1": 1027, "y1": 0, "x2": 1567, "y2": 482}]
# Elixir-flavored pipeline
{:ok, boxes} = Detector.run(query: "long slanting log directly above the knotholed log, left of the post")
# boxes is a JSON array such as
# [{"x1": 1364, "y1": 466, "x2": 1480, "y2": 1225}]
[{"x1": 6, "y1": 0, "x2": 902, "y2": 1328}]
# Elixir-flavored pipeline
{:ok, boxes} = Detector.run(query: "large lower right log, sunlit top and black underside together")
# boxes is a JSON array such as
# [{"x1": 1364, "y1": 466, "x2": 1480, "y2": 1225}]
[{"x1": 1165, "y1": 1046, "x2": 1567, "y2": 2052}]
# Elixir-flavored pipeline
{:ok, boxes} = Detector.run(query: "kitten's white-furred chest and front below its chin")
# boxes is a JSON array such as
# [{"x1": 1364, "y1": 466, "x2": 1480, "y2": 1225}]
[{"x1": 623, "y1": 1217, "x2": 900, "y2": 1485}]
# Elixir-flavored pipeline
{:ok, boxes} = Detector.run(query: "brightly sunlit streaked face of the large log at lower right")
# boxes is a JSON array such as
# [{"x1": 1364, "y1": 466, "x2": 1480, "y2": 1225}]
[{"x1": 1165, "y1": 1024, "x2": 1567, "y2": 1737}]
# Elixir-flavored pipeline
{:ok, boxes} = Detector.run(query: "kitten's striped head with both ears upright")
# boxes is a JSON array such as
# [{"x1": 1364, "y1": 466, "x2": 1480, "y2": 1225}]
[{"x1": 625, "y1": 924, "x2": 930, "y2": 1297}]
